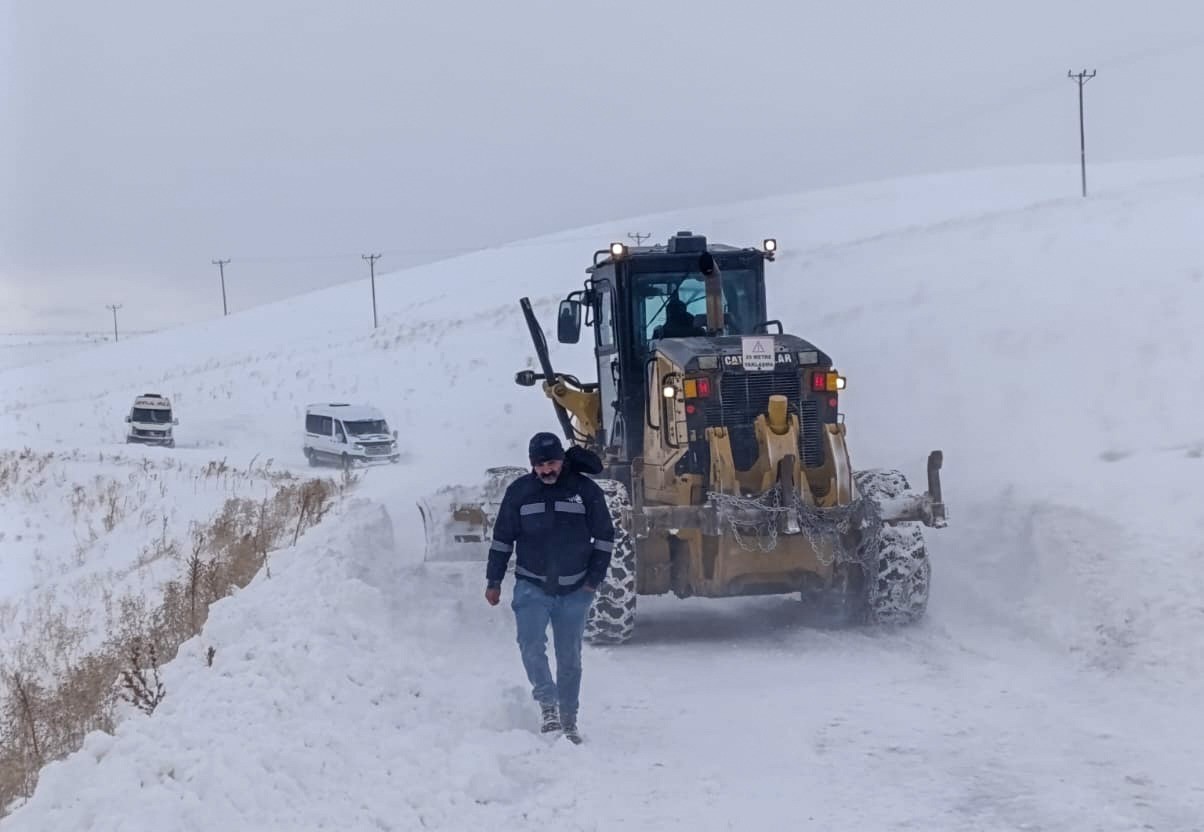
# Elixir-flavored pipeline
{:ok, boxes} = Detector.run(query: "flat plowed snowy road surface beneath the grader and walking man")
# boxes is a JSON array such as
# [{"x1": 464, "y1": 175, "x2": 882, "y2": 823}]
[{"x1": 378, "y1": 498, "x2": 1204, "y2": 830}]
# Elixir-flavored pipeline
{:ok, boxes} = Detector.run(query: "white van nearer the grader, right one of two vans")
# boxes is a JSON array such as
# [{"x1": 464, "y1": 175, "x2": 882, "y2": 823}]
[{"x1": 303, "y1": 402, "x2": 401, "y2": 467}]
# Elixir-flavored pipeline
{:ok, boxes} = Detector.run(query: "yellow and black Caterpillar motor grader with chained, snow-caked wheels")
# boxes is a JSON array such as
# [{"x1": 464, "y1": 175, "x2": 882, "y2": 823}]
[{"x1": 419, "y1": 231, "x2": 946, "y2": 643}]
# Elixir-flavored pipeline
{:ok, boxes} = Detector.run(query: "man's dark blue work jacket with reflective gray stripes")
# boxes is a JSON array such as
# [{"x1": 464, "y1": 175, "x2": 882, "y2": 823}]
[{"x1": 485, "y1": 466, "x2": 614, "y2": 595}]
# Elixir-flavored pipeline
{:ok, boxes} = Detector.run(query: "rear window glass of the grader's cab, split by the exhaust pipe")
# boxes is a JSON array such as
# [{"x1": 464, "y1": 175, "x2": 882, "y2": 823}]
[{"x1": 633, "y1": 270, "x2": 757, "y2": 352}]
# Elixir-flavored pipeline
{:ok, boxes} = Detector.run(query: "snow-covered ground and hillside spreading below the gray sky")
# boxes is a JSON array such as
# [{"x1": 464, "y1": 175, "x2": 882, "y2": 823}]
[{"x1": 0, "y1": 159, "x2": 1204, "y2": 832}]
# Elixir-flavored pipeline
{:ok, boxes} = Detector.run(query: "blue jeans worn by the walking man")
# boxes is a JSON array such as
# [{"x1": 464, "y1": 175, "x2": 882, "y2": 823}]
[{"x1": 510, "y1": 579, "x2": 594, "y2": 719}]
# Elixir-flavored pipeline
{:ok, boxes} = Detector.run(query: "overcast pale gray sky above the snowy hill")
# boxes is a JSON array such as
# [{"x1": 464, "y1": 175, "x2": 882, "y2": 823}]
[{"x1": 0, "y1": 0, "x2": 1204, "y2": 331}]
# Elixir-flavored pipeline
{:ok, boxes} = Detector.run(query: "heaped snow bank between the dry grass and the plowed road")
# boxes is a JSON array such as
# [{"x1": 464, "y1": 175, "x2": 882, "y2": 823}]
[{"x1": 5, "y1": 501, "x2": 549, "y2": 832}]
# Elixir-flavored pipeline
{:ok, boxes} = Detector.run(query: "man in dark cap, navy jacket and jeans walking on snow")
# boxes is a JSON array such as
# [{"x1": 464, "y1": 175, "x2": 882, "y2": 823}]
[{"x1": 485, "y1": 433, "x2": 614, "y2": 743}]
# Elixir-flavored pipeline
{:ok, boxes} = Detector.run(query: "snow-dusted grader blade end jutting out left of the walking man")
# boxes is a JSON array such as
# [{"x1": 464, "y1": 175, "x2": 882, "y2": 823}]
[{"x1": 418, "y1": 466, "x2": 526, "y2": 562}]
